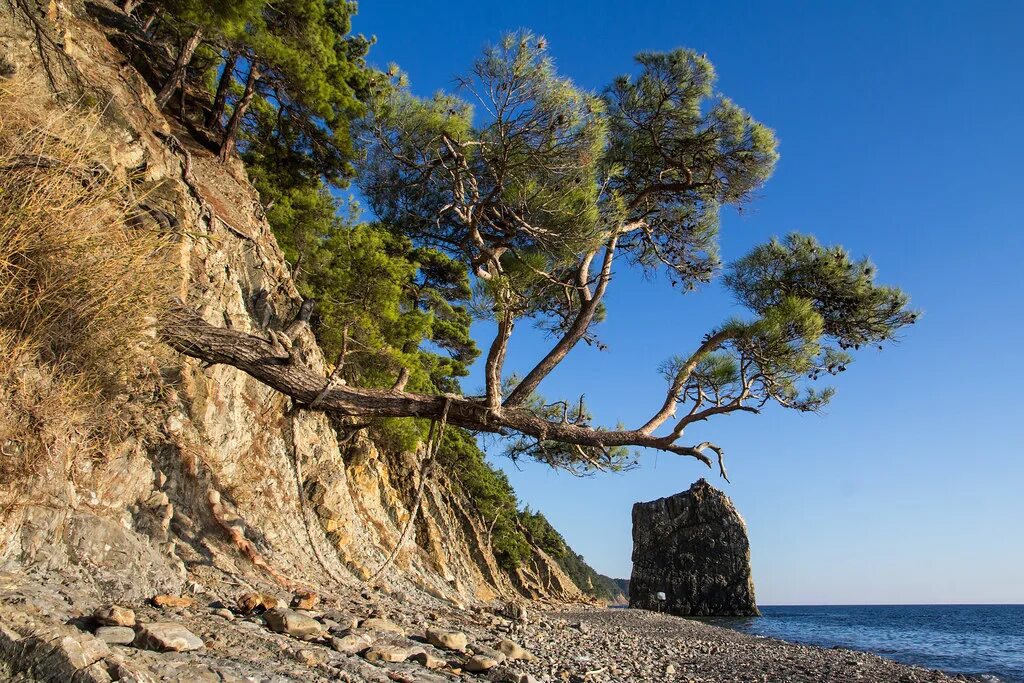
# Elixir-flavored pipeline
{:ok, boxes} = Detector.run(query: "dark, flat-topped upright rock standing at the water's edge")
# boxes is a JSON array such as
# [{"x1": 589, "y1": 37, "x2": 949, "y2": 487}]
[{"x1": 630, "y1": 479, "x2": 758, "y2": 616}]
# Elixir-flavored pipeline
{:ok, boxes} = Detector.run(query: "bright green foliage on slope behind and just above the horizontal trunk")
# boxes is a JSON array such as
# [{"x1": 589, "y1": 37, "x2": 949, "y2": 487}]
[{"x1": 260, "y1": 186, "x2": 478, "y2": 393}]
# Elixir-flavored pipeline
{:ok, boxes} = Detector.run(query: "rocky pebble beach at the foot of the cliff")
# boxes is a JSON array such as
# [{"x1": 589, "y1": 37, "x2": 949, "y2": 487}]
[{"x1": 0, "y1": 573, "x2": 976, "y2": 683}]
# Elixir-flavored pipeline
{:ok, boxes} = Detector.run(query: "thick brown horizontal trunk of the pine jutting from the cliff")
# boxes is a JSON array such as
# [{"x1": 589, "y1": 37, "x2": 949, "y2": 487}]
[{"x1": 161, "y1": 306, "x2": 714, "y2": 467}]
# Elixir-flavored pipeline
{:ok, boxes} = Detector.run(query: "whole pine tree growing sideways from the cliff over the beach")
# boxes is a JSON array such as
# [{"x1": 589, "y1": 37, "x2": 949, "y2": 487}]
[{"x1": 166, "y1": 33, "x2": 915, "y2": 476}]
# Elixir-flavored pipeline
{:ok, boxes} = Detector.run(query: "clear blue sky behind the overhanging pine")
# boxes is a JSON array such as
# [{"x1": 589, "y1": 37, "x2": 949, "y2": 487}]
[{"x1": 354, "y1": 0, "x2": 1024, "y2": 604}]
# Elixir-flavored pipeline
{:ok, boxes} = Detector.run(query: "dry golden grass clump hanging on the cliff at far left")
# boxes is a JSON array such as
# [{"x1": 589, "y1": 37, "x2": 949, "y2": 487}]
[{"x1": 0, "y1": 80, "x2": 170, "y2": 487}]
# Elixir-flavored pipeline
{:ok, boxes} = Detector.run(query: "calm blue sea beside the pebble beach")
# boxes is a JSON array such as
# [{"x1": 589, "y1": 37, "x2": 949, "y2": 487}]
[{"x1": 702, "y1": 605, "x2": 1024, "y2": 683}]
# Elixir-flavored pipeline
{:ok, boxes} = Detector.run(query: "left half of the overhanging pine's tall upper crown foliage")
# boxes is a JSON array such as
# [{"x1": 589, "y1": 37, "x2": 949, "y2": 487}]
[{"x1": 360, "y1": 33, "x2": 604, "y2": 267}]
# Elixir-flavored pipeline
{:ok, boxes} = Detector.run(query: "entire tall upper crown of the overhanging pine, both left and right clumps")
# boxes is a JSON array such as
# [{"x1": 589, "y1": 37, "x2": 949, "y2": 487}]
[{"x1": 360, "y1": 33, "x2": 777, "y2": 307}]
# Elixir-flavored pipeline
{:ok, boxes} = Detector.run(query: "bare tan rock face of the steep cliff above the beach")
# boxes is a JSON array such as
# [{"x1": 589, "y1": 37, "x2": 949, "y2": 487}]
[{"x1": 0, "y1": 0, "x2": 581, "y2": 604}]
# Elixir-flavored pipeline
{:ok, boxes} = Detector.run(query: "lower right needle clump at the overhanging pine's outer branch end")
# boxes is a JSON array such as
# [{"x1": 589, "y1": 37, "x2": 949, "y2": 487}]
[{"x1": 663, "y1": 234, "x2": 919, "y2": 422}]
